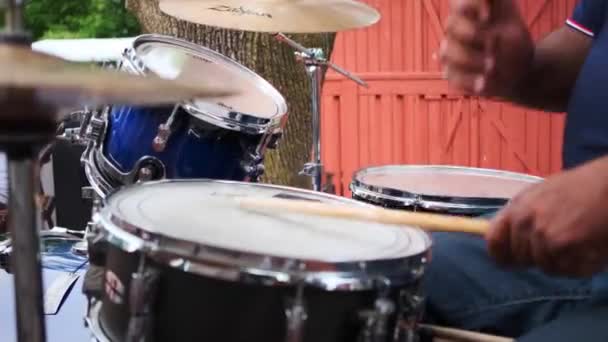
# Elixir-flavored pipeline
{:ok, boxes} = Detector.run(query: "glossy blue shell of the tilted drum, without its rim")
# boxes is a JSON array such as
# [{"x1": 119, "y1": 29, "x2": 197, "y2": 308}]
[{"x1": 103, "y1": 106, "x2": 262, "y2": 181}]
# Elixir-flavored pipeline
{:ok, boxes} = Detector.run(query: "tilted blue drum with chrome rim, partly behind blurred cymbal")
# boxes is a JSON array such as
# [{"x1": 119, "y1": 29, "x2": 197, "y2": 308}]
[{"x1": 83, "y1": 35, "x2": 287, "y2": 197}]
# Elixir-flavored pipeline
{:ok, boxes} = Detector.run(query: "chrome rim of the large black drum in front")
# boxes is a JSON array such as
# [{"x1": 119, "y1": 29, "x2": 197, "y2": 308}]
[{"x1": 93, "y1": 179, "x2": 432, "y2": 291}]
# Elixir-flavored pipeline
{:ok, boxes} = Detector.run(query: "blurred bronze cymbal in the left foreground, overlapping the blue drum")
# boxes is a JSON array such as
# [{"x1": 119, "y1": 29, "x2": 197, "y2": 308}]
[{"x1": 0, "y1": 44, "x2": 239, "y2": 107}]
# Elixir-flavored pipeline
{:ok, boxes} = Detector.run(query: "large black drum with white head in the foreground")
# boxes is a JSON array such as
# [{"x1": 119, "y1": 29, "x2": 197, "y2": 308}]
[{"x1": 88, "y1": 180, "x2": 431, "y2": 342}]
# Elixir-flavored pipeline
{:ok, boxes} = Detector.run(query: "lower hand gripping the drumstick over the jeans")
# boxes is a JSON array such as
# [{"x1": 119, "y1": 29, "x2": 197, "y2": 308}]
[{"x1": 486, "y1": 158, "x2": 608, "y2": 277}]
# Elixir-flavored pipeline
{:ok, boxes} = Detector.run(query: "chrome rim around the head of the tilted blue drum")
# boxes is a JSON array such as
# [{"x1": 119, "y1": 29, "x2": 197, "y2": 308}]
[{"x1": 123, "y1": 34, "x2": 288, "y2": 134}]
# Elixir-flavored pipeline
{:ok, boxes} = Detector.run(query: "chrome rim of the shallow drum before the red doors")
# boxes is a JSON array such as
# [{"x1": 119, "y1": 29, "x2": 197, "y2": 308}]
[{"x1": 350, "y1": 164, "x2": 544, "y2": 212}]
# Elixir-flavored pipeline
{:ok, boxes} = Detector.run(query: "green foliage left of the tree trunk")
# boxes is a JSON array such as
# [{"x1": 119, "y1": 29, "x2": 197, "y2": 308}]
[{"x1": 25, "y1": 0, "x2": 140, "y2": 40}]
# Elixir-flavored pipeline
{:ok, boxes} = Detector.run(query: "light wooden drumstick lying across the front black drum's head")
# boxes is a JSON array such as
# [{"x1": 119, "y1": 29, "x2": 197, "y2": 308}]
[{"x1": 237, "y1": 197, "x2": 490, "y2": 236}]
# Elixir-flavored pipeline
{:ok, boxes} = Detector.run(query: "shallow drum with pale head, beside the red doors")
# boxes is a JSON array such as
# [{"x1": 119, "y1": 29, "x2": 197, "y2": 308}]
[{"x1": 351, "y1": 165, "x2": 542, "y2": 216}]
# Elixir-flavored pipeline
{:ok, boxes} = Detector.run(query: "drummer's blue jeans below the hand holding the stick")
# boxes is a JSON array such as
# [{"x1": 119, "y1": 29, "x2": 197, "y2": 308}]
[{"x1": 424, "y1": 233, "x2": 608, "y2": 342}]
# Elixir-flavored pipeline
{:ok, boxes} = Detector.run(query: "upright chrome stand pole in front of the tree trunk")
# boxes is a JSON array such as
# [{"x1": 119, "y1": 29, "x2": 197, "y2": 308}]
[{"x1": 306, "y1": 62, "x2": 323, "y2": 191}]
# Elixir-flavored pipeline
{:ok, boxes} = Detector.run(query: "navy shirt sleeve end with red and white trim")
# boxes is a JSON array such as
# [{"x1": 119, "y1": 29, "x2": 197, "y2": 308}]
[{"x1": 566, "y1": 0, "x2": 606, "y2": 37}]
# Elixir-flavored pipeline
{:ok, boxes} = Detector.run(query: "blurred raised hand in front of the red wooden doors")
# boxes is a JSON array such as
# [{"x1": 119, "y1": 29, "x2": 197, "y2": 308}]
[{"x1": 439, "y1": 0, "x2": 534, "y2": 96}]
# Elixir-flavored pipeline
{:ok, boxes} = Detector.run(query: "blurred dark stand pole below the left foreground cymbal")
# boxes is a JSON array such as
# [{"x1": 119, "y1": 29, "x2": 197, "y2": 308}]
[{"x1": 8, "y1": 152, "x2": 46, "y2": 342}]
